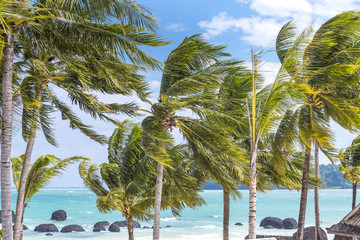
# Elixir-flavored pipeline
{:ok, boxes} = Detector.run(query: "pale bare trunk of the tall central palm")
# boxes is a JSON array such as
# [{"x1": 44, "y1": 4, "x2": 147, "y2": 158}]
[{"x1": 153, "y1": 163, "x2": 164, "y2": 240}]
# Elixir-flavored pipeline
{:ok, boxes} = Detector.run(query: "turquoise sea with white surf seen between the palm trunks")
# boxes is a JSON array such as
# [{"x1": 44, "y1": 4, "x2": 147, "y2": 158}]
[{"x1": 5, "y1": 188, "x2": 351, "y2": 240}]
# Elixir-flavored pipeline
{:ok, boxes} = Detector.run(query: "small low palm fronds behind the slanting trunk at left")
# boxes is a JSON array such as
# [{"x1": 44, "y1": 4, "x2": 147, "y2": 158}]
[{"x1": 11, "y1": 154, "x2": 88, "y2": 226}]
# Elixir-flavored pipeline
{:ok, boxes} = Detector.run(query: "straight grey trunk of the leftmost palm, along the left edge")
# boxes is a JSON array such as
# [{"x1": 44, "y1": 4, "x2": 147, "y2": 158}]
[{"x1": 1, "y1": 30, "x2": 14, "y2": 240}]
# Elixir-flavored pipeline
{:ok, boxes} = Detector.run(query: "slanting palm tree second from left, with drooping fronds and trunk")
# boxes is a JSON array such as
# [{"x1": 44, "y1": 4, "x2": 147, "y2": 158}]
[{"x1": 14, "y1": 45, "x2": 150, "y2": 240}]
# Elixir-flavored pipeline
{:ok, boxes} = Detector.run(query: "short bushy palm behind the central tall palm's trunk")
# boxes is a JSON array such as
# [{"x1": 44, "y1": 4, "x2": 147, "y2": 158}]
[{"x1": 79, "y1": 124, "x2": 204, "y2": 240}]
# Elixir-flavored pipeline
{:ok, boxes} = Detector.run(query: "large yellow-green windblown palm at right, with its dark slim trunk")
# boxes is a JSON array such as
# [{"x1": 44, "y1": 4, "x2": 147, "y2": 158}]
[{"x1": 277, "y1": 13, "x2": 359, "y2": 239}]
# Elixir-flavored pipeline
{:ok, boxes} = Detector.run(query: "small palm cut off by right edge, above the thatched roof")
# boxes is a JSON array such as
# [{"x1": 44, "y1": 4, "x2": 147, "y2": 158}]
[{"x1": 339, "y1": 137, "x2": 360, "y2": 209}]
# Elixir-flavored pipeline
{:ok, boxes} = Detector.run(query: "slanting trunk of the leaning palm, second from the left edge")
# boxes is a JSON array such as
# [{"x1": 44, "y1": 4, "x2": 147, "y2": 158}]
[{"x1": 14, "y1": 82, "x2": 42, "y2": 240}]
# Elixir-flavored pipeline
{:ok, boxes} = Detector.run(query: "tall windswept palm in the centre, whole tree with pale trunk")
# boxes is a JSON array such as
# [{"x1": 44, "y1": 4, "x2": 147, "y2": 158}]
[{"x1": 142, "y1": 35, "x2": 242, "y2": 240}]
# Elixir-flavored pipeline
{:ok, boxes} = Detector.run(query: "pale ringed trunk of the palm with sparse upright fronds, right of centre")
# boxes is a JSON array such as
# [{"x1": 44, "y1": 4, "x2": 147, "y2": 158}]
[{"x1": 249, "y1": 147, "x2": 257, "y2": 239}]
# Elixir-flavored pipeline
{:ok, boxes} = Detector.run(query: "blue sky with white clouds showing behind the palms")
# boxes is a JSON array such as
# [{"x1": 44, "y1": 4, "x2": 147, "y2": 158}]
[{"x1": 12, "y1": 0, "x2": 360, "y2": 187}]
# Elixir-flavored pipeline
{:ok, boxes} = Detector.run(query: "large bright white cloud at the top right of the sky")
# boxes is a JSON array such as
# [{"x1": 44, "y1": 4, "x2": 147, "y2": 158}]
[{"x1": 199, "y1": 0, "x2": 360, "y2": 47}]
